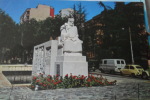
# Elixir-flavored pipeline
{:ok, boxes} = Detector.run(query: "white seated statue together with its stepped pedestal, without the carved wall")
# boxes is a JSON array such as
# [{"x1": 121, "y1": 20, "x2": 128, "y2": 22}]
[{"x1": 56, "y1": 18, "x2": 88, "y2": 77}]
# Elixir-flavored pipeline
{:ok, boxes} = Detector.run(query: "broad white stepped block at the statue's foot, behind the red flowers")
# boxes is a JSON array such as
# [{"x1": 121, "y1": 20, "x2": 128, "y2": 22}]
[{"x1": 55, "y1": 56, "x2": 88, "y2": 77}]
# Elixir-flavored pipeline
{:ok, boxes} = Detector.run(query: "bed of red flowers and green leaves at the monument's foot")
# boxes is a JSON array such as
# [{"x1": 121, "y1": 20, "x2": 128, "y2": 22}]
[{"x1": 31, "y1": 74, "x2": 116, "y2": 89}]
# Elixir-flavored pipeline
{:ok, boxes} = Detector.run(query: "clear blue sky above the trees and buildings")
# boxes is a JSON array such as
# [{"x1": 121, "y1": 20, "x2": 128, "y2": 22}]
[{"x1": 0, "y1": 0, "x2": 140, "y2": 23}]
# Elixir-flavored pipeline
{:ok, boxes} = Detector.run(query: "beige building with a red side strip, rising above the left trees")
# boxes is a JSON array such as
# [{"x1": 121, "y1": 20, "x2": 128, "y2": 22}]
[{"x1": 20, "y1": 4, "x2": 54, "y2": 23}]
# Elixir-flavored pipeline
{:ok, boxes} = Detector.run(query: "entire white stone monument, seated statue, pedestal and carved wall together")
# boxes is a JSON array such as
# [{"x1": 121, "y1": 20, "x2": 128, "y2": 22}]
[{"x1": 32, "y1": 18, "x2": 88, "y2": 77}]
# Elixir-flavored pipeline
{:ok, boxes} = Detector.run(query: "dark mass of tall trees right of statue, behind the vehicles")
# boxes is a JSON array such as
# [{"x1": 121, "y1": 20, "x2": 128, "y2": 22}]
[{"x1": 85, "y1": 2, "x2": 148, "y2": 64}]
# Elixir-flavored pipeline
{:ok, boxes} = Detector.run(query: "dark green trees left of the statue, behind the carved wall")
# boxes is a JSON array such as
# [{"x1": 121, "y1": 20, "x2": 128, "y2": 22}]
[{"x1": 0, "y1": 9, "x2": 67, "y2": 63}]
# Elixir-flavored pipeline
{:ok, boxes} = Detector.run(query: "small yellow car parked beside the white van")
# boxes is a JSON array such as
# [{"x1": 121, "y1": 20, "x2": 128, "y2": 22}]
[{"x1": 120, "y1": 64, "x2": 144, "y2": 77}]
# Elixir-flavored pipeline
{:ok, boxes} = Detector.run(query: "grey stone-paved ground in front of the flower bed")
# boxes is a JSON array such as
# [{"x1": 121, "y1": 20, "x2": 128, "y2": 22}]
[{"x1": 0, "y1": 83, "x2": 150, "y2": 100}]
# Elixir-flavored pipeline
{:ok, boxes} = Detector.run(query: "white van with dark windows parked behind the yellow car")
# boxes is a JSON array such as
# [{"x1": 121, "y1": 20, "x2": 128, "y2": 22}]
[{"x1": 99, "y1": 59, "x2": 126, "y2": 73}]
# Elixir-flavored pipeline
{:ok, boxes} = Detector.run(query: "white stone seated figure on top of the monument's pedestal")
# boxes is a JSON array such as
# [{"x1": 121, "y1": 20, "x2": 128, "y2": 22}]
[{"x1": 60, "y1": 18, "x2": 83, "y2": 56}]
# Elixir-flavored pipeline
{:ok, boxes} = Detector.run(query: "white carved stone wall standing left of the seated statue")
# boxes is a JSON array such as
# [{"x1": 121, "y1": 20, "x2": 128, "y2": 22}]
[{"x1": 32, "y1": 40, "x2": 58, "y2": 75}]
